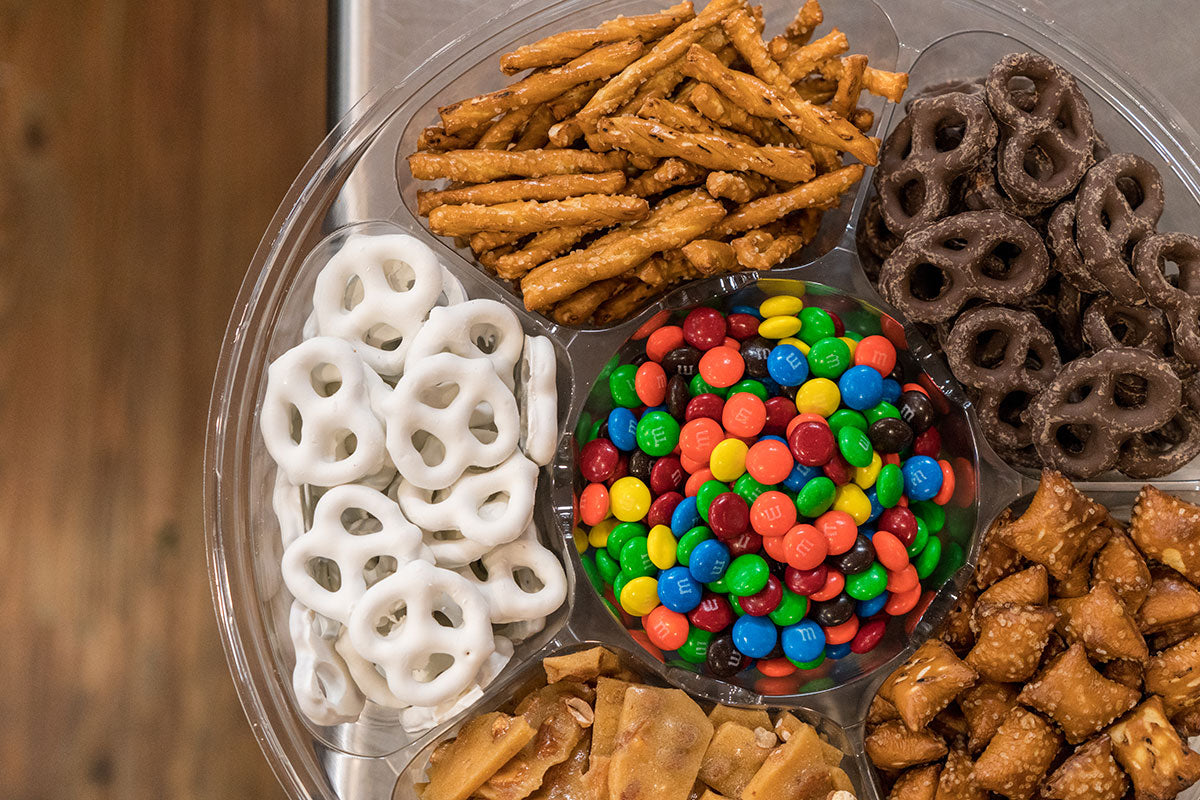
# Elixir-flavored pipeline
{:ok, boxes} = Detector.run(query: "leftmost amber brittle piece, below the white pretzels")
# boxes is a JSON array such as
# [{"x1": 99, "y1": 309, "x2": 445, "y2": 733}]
[{"x1": 422, "y1": 711, "x2": 536, "y2": 800}]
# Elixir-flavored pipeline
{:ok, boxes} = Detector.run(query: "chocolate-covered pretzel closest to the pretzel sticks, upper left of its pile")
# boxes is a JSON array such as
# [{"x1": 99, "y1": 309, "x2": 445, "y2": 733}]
[{"x1": 875, "y1": 92, "x2": 997, "y2": 236}]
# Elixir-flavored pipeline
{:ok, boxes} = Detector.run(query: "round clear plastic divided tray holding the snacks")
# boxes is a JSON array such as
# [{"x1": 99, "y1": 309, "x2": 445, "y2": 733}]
[{"x1": 206, "y1": 0, "x2": 1200, "y2": 798}]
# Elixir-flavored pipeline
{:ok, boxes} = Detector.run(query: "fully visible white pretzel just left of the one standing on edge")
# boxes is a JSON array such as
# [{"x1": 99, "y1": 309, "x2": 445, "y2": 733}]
[{"x1": 384, "y1": 353, "x2": 520, "y2": 489}]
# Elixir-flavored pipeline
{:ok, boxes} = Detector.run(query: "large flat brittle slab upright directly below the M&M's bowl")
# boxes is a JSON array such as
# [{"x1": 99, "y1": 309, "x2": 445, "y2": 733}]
[{"x1": 608, "y1": 686, "x2": 713, "y2": 800}]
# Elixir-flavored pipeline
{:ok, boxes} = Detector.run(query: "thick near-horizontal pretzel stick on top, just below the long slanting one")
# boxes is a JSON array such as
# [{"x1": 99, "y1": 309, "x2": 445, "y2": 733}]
[{"x1": 596, "y1": 116, "x2": 816, "y2": 182}]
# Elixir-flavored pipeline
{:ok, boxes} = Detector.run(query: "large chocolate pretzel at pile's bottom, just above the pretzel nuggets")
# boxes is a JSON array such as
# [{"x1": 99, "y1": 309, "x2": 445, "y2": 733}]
[{"x1": 1027, "y1": 348, "x2": 1182, "y2": 479}]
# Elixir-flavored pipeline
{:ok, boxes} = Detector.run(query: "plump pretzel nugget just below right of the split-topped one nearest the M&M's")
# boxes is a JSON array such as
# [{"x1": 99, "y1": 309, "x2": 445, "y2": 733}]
[{"x1": 971, "y1": 706, "x2": 1062, "y2": 800}]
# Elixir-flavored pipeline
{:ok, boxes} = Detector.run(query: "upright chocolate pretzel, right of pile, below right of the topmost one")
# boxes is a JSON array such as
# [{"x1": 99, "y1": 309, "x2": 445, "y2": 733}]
[{"x1": 1075, "y1": 152, "x2": 1163, "y2": 303}]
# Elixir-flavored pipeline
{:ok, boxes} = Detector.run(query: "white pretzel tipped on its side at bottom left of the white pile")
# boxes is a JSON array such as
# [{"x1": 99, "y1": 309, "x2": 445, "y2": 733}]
[{"x1": 288, "y1": 600, "x2": 365, "y2": 726}]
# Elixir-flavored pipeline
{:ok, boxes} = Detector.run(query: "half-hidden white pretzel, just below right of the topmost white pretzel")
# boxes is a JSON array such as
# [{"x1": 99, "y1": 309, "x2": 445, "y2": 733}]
[{"x1": 409, "y1": 300, "x2": 524, "y2": 390}]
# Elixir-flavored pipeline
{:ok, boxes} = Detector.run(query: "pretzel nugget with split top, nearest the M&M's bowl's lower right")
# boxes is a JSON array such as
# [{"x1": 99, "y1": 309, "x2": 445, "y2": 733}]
[{"x1": 880, "y1": 639, "x2": 978, "y2": 730}]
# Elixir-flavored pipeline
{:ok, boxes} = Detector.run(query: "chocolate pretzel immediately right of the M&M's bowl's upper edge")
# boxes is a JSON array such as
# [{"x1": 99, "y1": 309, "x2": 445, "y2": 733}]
[{"x1": 946, "y1": 306, "x2": 1061, "y2": 451}]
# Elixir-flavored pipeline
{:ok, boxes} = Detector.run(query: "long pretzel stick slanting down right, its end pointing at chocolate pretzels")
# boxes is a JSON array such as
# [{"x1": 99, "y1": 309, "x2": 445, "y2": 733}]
[{"x1": 684, "y1": 47, "x2": 878, "y2": 164}]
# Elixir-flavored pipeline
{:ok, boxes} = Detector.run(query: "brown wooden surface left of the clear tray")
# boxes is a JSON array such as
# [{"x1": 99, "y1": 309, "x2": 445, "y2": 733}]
[{"x1": 0, "y1": 0, "x2": 325, "y2": 800}]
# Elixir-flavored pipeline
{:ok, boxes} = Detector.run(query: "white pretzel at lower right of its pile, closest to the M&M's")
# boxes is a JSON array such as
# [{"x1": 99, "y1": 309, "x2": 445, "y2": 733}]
[{"x1": 458, "y1": 534, "x2": 566, "y2": 624}]
